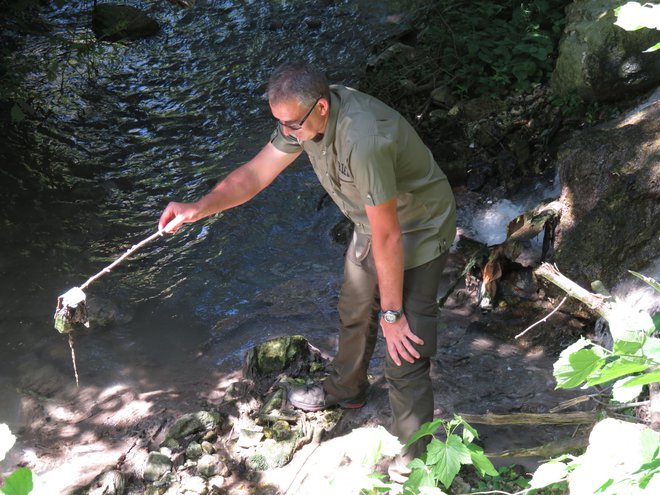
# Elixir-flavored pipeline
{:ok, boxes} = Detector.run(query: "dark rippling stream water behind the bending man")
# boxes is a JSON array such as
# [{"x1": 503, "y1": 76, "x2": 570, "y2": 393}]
[{"x1": 0, "y1": 0, "x2": 422, "y2": 431}]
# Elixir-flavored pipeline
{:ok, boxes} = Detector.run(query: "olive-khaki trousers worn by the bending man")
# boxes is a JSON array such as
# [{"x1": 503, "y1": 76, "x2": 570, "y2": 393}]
[{"x1": 324, "y1": 234, "x2": 447, "y2": 461}]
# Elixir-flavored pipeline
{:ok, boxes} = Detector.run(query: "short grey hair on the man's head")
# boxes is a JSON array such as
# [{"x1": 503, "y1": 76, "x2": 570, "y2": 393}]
[{"x1": 268, "y1": 62, "x2": 330, "y2": 105}]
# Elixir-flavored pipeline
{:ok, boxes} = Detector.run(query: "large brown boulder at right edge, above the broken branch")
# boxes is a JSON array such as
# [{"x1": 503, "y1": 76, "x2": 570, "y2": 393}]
[{"x1": 554, "y1": 90, "x2": 660, "y2": 287}]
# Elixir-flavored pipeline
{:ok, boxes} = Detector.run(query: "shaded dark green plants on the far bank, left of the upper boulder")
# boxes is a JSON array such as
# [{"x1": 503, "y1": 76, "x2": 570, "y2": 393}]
[{"x1": 364, "y1": 0, "x2": 570, "y2": 106}]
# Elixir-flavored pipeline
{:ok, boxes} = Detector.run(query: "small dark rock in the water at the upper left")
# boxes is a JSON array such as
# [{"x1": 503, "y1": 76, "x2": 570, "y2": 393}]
[{"x1": 92, "y1": 3, "x2": 160, "y2": 41}]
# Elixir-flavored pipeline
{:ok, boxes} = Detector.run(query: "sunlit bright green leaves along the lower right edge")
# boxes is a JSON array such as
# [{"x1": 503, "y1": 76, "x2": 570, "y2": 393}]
[{"x1": 531, "y1": 272, "x2": 660, "y2": 495}]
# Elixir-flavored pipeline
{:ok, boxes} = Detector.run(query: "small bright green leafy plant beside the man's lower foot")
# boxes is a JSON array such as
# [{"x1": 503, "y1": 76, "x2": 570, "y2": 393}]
[{"x1": 403, "y1": 415, "x2": 498, "y2": 493}]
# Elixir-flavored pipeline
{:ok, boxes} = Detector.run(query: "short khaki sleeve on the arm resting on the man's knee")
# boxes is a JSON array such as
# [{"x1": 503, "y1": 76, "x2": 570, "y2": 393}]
[{"x1": 349, "y1": 136, "x2": 397, "y2": 206}]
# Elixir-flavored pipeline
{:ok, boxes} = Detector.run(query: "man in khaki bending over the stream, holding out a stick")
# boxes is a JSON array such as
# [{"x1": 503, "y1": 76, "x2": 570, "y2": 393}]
[{"x1": 159, "y1": 63, "x2": 456, "y2": 476}]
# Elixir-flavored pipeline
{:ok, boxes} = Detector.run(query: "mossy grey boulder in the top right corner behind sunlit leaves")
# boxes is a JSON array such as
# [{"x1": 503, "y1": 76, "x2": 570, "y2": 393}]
[{"x1": 552, "y1": 0, "x2": 660, "y2": 101}]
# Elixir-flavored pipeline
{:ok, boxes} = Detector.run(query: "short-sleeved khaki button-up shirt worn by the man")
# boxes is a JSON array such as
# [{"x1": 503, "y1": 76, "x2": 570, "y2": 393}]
[{"x1": 271, "y1": 85, "x2": 456, "y2": 269}]
